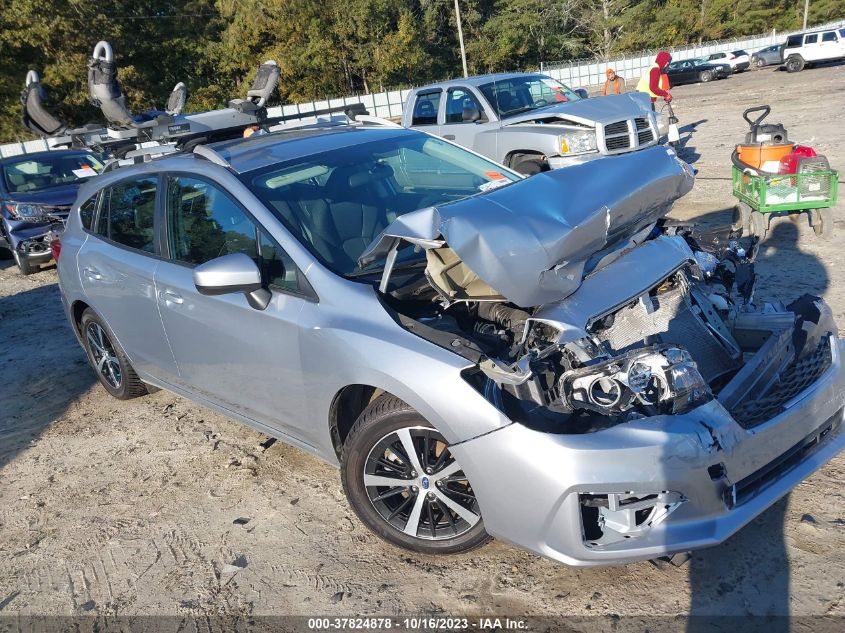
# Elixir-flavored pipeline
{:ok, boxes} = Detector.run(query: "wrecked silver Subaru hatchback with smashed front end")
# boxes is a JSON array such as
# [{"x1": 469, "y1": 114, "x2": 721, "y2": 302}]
[{"x1": 58, "y1": 127, "x2": 845, "y2": 565}]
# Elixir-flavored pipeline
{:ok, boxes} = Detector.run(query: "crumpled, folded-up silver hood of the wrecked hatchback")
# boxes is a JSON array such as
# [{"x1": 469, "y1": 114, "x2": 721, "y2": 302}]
[{"x1": 358, "y1": 146, "x2": 694, "y2": 307}]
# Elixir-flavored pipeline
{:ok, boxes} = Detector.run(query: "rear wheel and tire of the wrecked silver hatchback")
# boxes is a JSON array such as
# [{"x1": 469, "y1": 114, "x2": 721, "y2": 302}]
[{"x1": 79, "y1": 308, "x2": 147, "y2": 400}]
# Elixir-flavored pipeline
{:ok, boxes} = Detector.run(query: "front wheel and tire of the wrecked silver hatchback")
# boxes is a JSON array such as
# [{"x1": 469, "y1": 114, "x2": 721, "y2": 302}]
[{"x1": 340, "y1": 394, "x2": 490, "y2": 554}]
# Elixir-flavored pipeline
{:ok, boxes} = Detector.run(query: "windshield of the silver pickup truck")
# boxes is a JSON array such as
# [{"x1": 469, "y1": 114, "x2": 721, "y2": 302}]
[{"x1": 480, "y1": 75, "x2": 581, "y2": 119}]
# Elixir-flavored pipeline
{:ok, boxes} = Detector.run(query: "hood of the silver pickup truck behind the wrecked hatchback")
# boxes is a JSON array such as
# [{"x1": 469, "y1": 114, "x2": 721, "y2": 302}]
[{"x1": 502, "y1": 92, "x2": 651, "y2": 125}]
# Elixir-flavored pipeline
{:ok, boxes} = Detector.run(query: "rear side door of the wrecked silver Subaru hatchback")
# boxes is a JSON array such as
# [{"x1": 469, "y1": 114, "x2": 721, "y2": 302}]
[{"x1": 77, "y1": 175, "x2": 176, "y2": 381}]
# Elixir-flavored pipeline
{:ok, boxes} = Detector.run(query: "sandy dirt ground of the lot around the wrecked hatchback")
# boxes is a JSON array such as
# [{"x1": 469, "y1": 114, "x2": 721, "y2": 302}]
[{"x1": 0, "y1": 60, "x2": 845, "y2": 630}]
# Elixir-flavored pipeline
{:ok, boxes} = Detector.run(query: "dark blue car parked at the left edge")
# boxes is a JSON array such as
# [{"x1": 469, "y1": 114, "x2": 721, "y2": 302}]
[{"x1": 0, "y1": 150, "x2": 103, "y2": 275}]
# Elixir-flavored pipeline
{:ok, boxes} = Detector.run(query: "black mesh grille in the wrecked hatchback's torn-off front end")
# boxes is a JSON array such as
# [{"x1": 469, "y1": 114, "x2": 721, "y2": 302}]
[{"x1": 730, "y1": 336, "x2": 832, "y2": 429}]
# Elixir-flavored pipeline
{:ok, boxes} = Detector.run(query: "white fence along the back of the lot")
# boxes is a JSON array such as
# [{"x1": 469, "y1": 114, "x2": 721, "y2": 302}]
[{"x1": 0, "y1": 20, "x2": 845, "y2": 158}]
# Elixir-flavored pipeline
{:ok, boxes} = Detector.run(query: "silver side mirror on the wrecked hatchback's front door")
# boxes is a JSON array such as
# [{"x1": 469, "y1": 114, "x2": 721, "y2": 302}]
[{"x1": 194, "y1": 253, "x2": 271, "y2": 310}]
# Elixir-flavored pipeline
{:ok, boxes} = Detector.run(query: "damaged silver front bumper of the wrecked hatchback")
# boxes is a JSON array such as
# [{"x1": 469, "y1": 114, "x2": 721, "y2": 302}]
[{"x1": 451, "y1": 337, "x2": 845, "y2": 565}]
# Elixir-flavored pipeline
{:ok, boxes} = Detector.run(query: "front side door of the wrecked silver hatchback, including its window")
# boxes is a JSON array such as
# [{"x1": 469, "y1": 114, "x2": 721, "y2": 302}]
[{"x1": 156, "y1": 175, "x2": 310, "y2": 432}]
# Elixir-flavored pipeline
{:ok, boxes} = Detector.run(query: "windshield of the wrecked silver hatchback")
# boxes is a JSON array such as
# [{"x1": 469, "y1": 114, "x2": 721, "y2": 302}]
[{"x1": 241, "y1": 134, "x2": 519, "y2": 275}]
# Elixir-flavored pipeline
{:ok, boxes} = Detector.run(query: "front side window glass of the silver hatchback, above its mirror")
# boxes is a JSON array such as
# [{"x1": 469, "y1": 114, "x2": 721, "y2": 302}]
[{"x1": 166, "y1": 176, "x2": 298, "y2": 290}]
